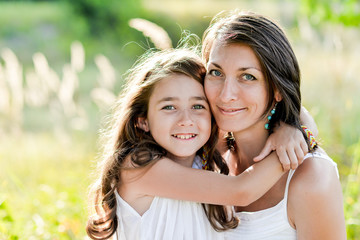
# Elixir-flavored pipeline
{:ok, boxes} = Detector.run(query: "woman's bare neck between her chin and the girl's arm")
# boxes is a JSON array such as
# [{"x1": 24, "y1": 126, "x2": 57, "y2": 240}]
[{"x1": 233, "y1": 126, "x2": 269, "y2": 170}]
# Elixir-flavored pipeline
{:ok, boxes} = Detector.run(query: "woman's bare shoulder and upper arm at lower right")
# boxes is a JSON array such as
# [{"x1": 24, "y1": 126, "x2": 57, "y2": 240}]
[{"x1": 288, "y1": 155, "x2": 346, "y2": 240}]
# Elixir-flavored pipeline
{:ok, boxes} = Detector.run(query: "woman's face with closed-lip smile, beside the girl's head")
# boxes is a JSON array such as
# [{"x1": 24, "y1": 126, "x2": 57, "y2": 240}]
[{"x1": 205, "y1": 41, "x2": 268, "y2": 132}]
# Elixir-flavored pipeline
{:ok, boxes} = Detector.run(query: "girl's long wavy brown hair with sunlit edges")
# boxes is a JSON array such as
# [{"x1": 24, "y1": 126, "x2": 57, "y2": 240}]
[{"x1": 86, "y1": 49, "x2": 237, "y2": 239}]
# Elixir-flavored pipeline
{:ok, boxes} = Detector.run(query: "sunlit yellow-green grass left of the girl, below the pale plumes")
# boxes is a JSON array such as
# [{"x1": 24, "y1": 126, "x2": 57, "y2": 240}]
[{"x1": 0, "y1": 134, "x2": 94, "y2": 239}]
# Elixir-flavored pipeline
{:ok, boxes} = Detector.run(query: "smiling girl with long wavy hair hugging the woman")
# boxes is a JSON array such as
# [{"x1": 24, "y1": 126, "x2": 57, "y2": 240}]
[{"x1": 87, "y1": 49, "x2": 310, "y2": 239}]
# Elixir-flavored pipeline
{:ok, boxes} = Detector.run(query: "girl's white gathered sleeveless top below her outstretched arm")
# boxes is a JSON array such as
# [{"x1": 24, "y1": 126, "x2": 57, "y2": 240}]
[{"x1": 115, "y1": 156, "x2": 224, "y2": 240}]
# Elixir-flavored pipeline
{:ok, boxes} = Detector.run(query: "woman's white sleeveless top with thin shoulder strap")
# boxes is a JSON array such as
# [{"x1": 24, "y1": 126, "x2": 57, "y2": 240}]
[{"x1": 225, "y1": 152, "x2": 339, "y2": 240}]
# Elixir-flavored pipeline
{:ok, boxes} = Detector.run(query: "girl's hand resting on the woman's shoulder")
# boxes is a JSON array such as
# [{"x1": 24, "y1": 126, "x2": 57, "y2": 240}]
[{"x1": 254, "y1": 123, "x2": 309, "y2": 171}]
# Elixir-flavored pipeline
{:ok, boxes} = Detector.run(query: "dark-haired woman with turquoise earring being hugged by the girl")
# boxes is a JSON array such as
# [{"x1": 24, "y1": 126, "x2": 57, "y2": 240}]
[{"x1": 202, "y1": 12, "x2": 346, "y2": 240}]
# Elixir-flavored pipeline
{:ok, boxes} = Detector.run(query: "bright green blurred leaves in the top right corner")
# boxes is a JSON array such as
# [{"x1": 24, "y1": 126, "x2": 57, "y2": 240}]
[{"x1": 301, "y1": 0, "x2": 360, "y2": 27}]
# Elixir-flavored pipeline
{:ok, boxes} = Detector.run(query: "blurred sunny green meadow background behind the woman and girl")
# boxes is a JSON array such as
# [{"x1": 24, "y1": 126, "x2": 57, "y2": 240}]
[{"x1": 0, "y1": 0, "x2": 360, "y2": 239}]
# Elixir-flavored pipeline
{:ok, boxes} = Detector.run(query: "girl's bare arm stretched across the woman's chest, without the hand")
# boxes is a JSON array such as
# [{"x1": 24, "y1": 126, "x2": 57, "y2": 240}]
[{"x1": 120, "y1": 153, "x2": 284, "y2": 206}]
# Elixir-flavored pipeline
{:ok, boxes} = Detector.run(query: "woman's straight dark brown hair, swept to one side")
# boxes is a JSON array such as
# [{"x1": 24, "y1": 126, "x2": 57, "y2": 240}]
[{"x1": 202, "y1": 10, "x2": 316, "y2": 150}]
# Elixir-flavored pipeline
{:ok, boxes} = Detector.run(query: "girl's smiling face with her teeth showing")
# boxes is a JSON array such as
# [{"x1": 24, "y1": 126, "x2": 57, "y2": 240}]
[{"x1": 139, "y1": 74, "x2": 211, "y2": 162}]
